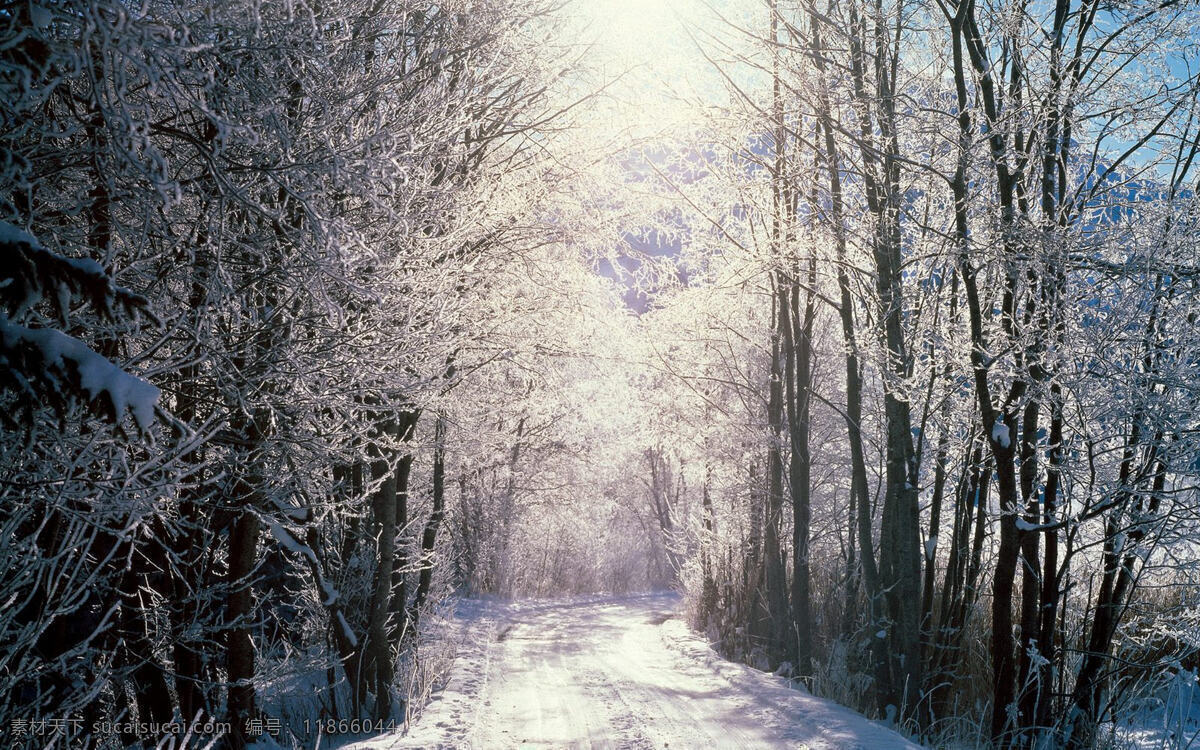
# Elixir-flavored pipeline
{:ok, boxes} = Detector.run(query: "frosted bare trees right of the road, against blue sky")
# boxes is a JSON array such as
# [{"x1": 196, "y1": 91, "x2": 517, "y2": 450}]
[{"x1": 659, "y1": 0, "x2": 1200, "y2": 748}]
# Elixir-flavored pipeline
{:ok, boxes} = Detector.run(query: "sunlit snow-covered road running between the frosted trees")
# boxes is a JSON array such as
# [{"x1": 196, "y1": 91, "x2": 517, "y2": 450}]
[{"x1": 353, "y1": 595, "x2": 916, "y2": 750}]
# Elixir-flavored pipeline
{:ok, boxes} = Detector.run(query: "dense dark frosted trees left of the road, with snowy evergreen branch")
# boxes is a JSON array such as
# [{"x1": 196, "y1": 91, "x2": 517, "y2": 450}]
[{"x1": 0, "y1": 0, "x2": 576, "y2": 748}]
